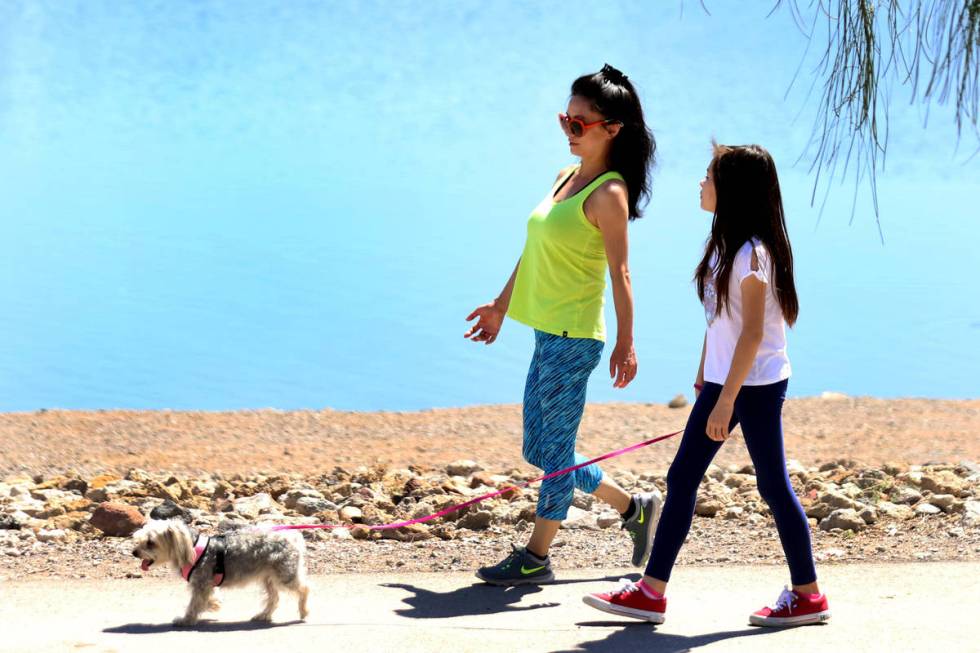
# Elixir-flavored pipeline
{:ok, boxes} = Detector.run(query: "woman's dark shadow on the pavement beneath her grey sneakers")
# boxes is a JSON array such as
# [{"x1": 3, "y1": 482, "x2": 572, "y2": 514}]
[{"x1": 381, "y1": 575, "x2": 622, "y2": 619}]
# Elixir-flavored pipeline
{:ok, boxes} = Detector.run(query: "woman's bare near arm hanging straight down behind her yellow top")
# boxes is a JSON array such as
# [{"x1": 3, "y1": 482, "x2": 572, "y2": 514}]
[{"x1": 584, "y1": 180, "x2": 637, "y2": 388}]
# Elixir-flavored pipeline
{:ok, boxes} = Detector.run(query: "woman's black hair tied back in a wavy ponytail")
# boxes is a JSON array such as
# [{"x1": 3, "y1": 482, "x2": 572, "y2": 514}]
[{"x1": 572, "y1": 64, "x2": 657, "y2": 220}]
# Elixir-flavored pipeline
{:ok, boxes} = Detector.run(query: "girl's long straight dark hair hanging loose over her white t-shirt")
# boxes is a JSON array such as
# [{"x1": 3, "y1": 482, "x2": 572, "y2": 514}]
[{"x1": 694, "y1": 143, "x2": 800, "y2": 326}]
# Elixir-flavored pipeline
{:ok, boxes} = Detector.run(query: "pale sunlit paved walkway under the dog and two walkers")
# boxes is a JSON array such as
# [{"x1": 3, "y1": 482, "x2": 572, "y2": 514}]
[{"x1": 0, "y1": 563, "x2": 980, "y2": 653}]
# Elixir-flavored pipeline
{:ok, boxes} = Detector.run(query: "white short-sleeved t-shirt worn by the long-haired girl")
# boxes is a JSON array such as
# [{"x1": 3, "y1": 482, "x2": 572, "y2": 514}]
[{"x1": 704, "y1": 238, "x2": 791, "y2": 385}]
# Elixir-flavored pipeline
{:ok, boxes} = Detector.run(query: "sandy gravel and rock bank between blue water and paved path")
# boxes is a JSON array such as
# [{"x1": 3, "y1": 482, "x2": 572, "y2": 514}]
[{"x1": 0, "y1": 398, "x2": 980, "y2": 580}]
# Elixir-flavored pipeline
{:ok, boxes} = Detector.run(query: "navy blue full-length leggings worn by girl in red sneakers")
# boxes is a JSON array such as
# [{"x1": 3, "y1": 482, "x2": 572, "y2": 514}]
[{"x1": 646, "y1": 381, "x2": 817, "y2": 585}]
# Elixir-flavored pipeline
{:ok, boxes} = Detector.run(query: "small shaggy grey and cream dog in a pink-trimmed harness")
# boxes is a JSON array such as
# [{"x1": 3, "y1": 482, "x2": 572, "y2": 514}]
[{"x1": 133, "y1": 519, "x2": 310, "y2": 626}]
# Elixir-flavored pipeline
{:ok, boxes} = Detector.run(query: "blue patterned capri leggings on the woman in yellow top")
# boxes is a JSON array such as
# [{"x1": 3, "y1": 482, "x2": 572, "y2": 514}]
[{"x1": 524, "y1": 330, "x2": 603, "y2": 521}]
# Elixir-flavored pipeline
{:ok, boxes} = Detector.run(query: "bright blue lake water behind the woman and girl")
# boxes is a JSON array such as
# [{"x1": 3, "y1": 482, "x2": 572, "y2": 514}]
[{"x1": 0, "y1": 1, "x2": 980, "y2": 411}]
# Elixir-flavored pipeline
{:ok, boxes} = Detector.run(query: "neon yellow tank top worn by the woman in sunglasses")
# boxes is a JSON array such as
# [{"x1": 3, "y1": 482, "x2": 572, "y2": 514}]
[{"x1": 507, "y1": 166, "x2": 623, "y2": 341}]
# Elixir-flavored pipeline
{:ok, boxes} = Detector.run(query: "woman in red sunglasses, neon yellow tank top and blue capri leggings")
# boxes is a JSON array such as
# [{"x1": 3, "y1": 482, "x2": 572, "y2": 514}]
[{"x1": 465, "y1": 65, "x2": 661, "y2": 585}]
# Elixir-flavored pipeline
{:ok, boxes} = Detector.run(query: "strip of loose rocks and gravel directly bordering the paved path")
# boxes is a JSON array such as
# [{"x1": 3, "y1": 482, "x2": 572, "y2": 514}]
[{"x1": 0, "y1": 459, "x2": 980, "y2": 579}]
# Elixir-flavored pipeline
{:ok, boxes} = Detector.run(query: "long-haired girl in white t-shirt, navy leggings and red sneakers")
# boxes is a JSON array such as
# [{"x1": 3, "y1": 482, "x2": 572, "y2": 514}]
[{"x1": 583, "y1": 144, "x2": 830, "y2": 626}]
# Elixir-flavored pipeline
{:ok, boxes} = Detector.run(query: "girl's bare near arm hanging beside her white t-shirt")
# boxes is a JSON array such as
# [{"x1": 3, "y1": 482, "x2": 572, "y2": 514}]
[{"x1": 707, "y1": 252, "x2": 766, "y2": 442}]
